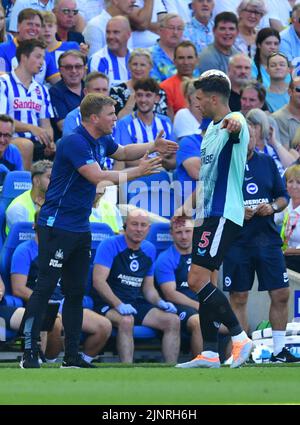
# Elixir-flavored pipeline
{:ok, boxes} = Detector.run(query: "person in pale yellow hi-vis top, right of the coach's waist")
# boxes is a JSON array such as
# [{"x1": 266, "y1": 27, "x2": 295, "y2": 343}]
[{"x1": 90, "y1": 187, "x2": 123, "y2": 233}]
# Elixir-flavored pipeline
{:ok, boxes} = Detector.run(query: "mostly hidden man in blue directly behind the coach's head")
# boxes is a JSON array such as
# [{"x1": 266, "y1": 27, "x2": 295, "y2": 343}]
[{"x1": 63, "y1": 71, "x2": 109, "y2": 136}]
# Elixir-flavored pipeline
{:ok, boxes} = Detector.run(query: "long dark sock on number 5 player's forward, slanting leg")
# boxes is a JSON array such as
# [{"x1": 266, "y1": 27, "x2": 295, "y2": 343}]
[{"x1": 198, "y1": 282, "x2": 243, "y2": 340}]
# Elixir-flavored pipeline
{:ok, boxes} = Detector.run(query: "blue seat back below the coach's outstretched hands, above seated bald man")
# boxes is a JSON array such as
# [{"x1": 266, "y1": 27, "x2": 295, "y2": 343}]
[{"x1": 119, "y1": 171, "x2": 174, "y2": 219}]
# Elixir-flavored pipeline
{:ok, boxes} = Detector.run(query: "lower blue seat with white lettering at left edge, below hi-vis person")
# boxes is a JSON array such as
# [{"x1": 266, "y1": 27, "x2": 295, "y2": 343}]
[{"x1": 0, "y1": 222, "x2": 34, "y2": 304}]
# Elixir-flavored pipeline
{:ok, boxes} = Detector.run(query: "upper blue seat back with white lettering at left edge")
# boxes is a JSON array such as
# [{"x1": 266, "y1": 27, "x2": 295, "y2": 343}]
[{"x1": 0, "y1": 171, "x2": 32, "y2": 208}]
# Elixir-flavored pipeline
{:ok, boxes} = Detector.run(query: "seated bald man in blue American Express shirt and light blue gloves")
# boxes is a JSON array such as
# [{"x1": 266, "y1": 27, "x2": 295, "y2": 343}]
[{"x1": 93, "y1": 209, "x2": 180, "y2": 363}]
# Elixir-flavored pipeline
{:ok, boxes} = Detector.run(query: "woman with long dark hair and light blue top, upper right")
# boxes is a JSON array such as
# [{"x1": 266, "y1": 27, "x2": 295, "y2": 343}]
[{"x1": 251, "y1": 28, "x2": 290, "y2": 89}]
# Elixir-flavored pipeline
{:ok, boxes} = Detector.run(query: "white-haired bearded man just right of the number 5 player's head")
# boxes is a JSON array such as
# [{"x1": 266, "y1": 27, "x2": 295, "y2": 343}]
[{"x1": 228, "y1": 53, "x2": 251, "y2": 111}]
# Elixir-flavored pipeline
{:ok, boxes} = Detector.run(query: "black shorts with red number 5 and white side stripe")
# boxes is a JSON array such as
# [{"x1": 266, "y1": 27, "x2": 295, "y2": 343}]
[{"x1": 192, "y1": 217, "x2": 241, "y2": 271}]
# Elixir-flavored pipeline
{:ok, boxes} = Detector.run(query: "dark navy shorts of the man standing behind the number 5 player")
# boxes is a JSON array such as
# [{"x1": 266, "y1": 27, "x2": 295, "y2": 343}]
[{"x1": 223, "y1": 246, "x2": 289, "y2": 292}]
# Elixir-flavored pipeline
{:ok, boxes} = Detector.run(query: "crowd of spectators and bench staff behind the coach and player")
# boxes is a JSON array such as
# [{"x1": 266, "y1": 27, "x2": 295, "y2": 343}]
[{"x1": 0, "y1": 0, "x2": 300, "y2": 362}]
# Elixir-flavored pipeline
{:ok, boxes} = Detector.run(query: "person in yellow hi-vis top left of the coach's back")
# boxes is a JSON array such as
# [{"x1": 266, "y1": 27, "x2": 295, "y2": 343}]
[{"x1": 5, "y1": 159, "x2": 53, "y2": 234}]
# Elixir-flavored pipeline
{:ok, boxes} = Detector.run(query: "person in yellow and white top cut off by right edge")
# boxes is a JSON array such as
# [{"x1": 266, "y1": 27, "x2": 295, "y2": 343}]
[{"x1": 281, "y1": 165, "x2": 300, "y2": 273}]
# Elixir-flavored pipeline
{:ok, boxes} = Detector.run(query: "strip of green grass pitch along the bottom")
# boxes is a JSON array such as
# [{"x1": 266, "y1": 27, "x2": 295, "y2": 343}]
[{"x1": 0, "y1": 363, "x2": 300, "y2": 404}]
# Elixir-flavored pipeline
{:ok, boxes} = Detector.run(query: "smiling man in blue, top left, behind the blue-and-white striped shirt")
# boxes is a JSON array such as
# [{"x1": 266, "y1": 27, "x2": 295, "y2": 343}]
[{"x1": 0, "y1": 9, "x2": 60, "y2": 84}]
